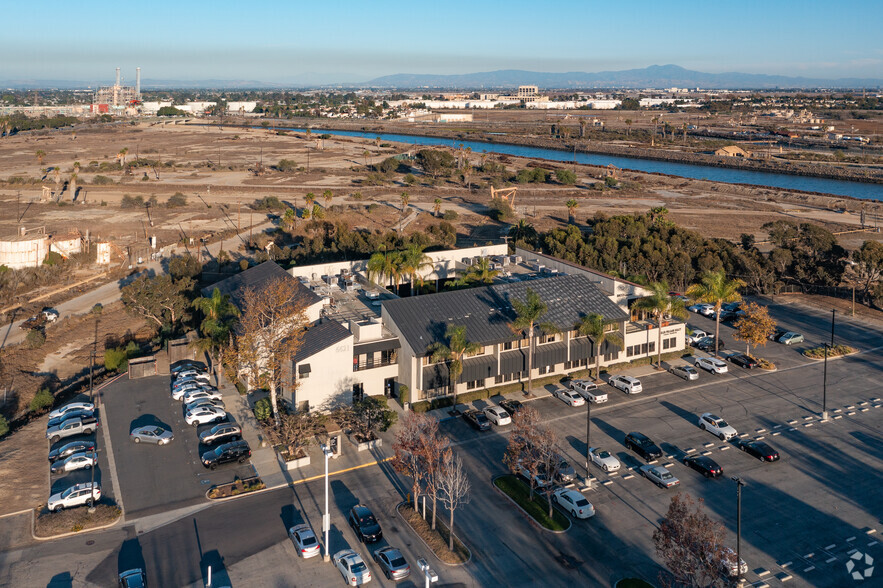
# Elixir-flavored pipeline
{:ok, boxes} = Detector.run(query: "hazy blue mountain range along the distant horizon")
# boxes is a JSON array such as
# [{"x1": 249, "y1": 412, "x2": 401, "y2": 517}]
[{"x1": 0, "y1": 65, "x2": 883, "y2": 90}]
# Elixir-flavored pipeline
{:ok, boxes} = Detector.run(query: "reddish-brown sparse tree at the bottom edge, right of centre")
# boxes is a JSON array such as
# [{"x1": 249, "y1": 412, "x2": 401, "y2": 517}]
[{"x1": 653, "y1": 492, "x2": 728, "y2": 587}]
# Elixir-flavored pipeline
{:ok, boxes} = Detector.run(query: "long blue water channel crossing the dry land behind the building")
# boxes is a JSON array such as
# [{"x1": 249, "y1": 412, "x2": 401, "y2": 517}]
[{"x1": 277, "y1": 127, "x2": 883, "y2": 201}]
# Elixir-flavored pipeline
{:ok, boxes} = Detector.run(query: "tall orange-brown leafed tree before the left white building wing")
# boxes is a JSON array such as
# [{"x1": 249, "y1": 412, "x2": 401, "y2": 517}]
[{"x1": 225, "y1": 279, "x2": 307, "y2": 427}]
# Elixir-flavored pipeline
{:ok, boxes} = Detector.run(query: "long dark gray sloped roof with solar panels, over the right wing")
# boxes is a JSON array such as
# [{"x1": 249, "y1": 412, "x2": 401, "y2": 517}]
[{"x1": 383, "y1": 275, "x2": 628, "y2": 354}]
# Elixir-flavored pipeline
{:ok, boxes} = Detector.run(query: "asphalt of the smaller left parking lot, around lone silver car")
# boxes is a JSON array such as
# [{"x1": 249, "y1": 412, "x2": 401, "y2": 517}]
[{"x1": 102, "y1": 376, "x2": 254, "y2": 519}]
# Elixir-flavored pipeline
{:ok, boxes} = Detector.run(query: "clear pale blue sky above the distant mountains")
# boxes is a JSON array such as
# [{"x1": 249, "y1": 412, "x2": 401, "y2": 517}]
[{"x1": 0, "y1": 0, "x2": 883, "y2": 83}]
